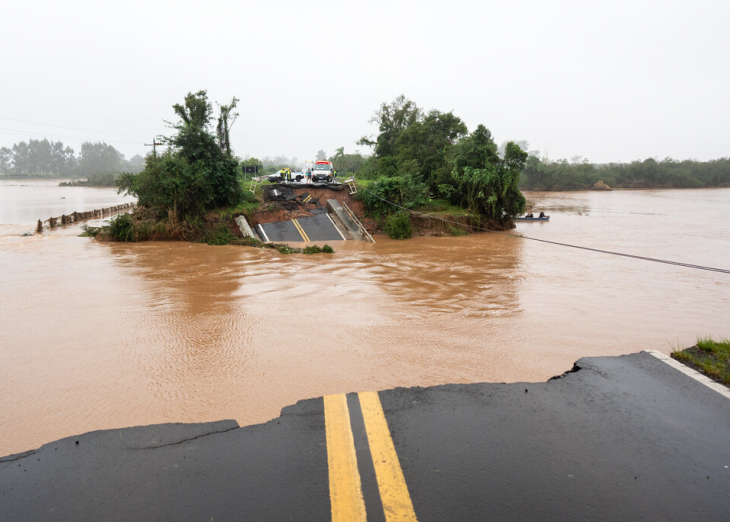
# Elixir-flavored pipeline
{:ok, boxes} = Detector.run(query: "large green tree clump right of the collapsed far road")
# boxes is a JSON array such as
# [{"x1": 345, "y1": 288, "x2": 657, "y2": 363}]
[{"x1": 352, "y1": 96, "x2": 528, "y2": 239}]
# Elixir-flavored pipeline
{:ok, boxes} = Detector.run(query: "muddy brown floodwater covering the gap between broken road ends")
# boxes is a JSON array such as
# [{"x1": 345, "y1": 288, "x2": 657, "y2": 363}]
[{"x1": 0, "y1": 183, "x2": 730, "y2": 455}]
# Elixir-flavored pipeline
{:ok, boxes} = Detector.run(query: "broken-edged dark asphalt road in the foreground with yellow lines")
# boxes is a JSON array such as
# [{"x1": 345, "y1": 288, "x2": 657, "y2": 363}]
[{"x1": 0, "y1": 353, "x2": 730, "y2": 521}]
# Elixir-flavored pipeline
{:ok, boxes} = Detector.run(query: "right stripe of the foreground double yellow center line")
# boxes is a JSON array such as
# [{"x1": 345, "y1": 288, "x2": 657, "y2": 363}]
[{"x1": 358, "y1": 392, "x2": 417, "y2": 522}]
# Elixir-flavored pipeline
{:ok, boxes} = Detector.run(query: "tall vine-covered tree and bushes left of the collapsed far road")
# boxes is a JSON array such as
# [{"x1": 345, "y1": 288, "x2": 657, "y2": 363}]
[{"x1": 83, "y1": 91, "x2": 333, "y2": 254}]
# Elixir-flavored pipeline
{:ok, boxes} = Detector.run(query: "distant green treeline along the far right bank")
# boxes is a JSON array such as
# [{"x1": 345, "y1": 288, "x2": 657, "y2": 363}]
[{"x1": 520, "y1": 156, "x2": 730, "y2": 191}]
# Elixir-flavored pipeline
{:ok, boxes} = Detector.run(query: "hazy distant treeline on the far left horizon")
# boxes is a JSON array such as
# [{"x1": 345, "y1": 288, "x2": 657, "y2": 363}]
[{"x1": 0, "y1": 138, "x2": 144, "y2": 178}]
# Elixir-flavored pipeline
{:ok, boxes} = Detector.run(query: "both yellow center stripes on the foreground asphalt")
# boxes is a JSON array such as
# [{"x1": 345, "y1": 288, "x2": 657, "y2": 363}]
[{"x1": 324, "y1": 392, "x2": 416, "y2": 522}]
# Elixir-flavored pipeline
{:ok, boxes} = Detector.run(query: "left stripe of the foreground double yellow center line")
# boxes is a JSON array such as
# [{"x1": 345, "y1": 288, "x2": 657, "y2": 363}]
[{"x1": 324, "y1": 395, "x2": 367, "y2": 522}]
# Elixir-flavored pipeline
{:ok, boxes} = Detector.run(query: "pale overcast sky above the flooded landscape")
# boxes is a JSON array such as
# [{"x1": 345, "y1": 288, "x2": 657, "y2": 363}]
[{"x1": 0, "y1": 0, "x2": 730, "y2": 162}]
